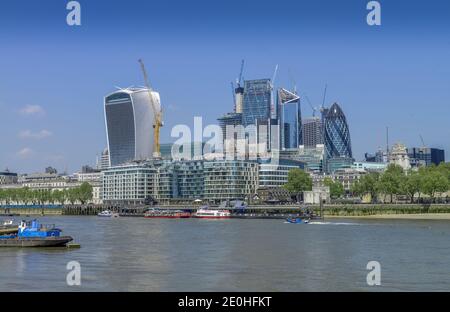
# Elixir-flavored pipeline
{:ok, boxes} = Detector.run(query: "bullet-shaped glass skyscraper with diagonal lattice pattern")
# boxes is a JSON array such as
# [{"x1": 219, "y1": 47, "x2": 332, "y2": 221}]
[{"x1": 323, "y1": 103, "x2": 353, "y2": 159}]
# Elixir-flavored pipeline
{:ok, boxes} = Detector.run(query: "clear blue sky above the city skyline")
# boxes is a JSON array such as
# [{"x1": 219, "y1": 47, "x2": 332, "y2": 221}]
[{"x1": 0, "y1": 0, "x2": 450, "y2": 172}]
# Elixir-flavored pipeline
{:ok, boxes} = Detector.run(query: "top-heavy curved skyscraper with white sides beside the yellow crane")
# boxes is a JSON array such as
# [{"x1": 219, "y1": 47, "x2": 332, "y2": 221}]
[{"x1": 104, "y1": 88, "x2": 160, "y2": 166}]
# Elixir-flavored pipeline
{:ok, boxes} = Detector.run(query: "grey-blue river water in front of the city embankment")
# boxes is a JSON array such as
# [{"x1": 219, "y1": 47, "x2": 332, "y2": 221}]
[{"x1": 0, "y1": 216, "x2": 450, "y2": 291}]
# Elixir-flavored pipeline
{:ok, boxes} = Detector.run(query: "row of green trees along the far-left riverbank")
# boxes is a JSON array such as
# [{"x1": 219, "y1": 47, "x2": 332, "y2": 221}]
[{"x1": 0, "y1": 182, "x2": 93, "y2": 205}]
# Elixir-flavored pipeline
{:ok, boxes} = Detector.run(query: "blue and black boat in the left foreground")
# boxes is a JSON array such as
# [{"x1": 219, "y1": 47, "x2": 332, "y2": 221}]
[{"x1": 0, "y1": 220, "x2": 73, "y2": 247}]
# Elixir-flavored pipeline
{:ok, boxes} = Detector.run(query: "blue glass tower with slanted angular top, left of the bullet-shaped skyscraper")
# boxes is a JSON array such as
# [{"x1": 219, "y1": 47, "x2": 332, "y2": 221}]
[{"x1": 278, "y1": 88, "x2": 303, "y2": 149}]
